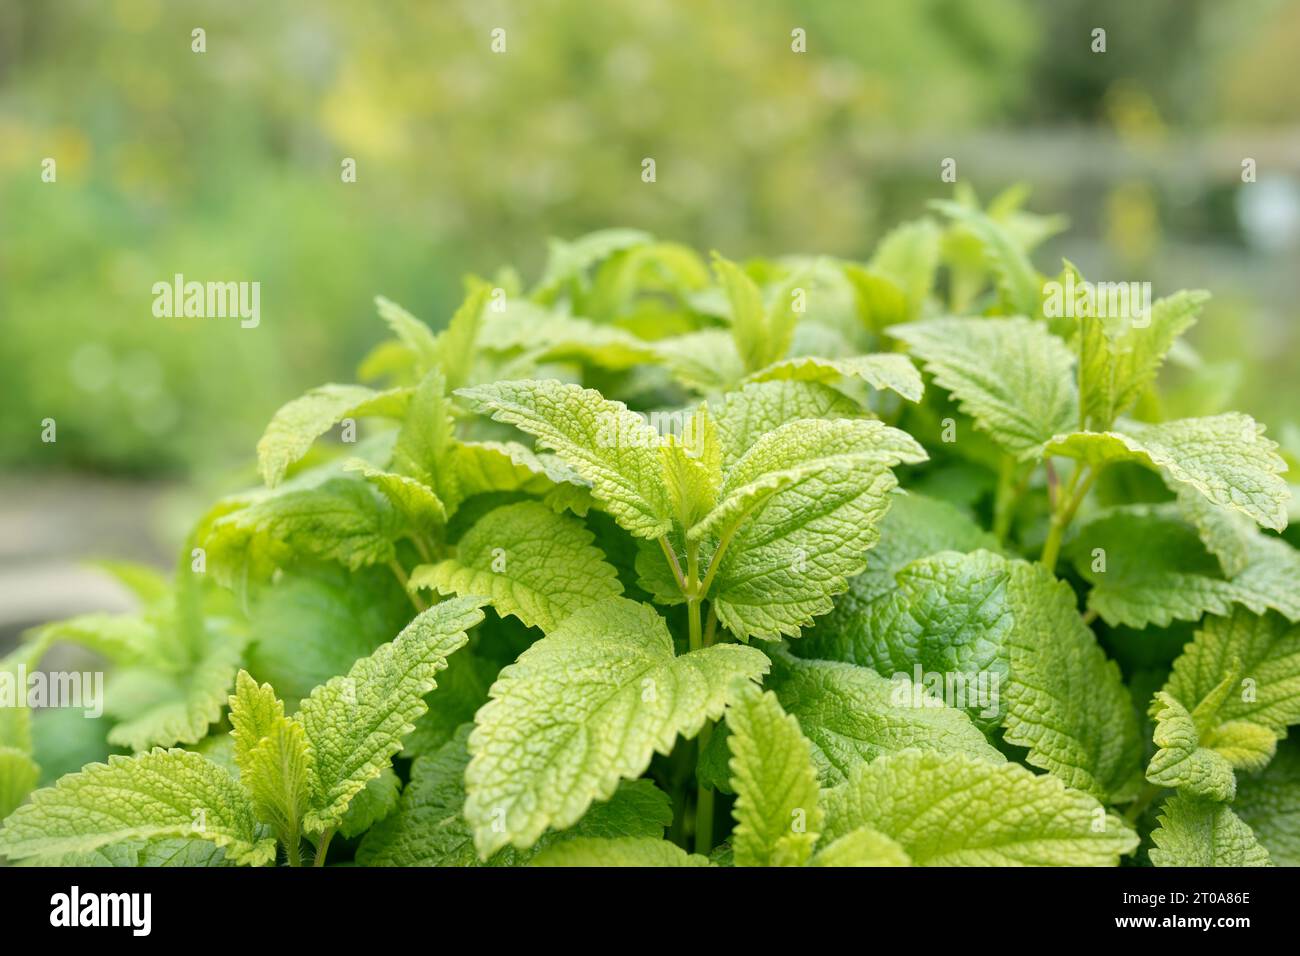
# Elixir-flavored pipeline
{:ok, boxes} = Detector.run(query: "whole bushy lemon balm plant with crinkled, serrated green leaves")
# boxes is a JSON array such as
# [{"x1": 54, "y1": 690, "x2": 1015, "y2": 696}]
[{"x1": 0, "y1": 193, "x2": 1300, "y2": 866}]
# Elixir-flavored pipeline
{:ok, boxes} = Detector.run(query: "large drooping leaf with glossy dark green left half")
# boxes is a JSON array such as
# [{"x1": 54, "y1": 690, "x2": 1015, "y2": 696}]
[{"x1": 810, "y1": 551, "x2": 1139, "y2": 797}]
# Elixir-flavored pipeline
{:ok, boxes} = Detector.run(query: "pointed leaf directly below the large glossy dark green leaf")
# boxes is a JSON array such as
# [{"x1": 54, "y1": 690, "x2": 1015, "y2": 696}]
[{"x1": 766, "y1": 650, "x2": 1005, "y2": 787}]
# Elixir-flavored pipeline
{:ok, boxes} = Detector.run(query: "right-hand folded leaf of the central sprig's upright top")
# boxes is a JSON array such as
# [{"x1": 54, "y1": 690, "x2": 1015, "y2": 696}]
[{"x1": 705, "y1": 420, "x2": 926, "y2": 639}]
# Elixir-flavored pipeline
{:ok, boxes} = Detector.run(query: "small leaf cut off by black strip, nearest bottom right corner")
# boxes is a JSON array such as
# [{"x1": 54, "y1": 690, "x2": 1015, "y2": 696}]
[{"x1": 1148, "y1": 793, "x2": 1273, "y2": 866}]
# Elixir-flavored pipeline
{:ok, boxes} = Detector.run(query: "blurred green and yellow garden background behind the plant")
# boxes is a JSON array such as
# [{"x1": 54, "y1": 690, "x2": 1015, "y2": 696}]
[{"x1": 0, "y1": 0, "x2": 1300, "y2": 623}]
